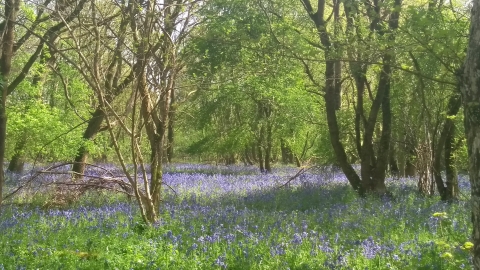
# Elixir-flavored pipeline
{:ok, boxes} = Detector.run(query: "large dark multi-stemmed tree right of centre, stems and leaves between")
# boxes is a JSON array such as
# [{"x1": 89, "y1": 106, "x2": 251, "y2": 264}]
[{"x1": 300, "y1": 0, "x2": 402, "y2": 195}]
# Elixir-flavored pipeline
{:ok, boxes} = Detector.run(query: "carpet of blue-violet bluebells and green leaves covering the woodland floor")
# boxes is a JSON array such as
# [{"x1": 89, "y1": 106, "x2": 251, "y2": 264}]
[{"x1": 0, "y1": 164, "x2": 471, "y2": 269}]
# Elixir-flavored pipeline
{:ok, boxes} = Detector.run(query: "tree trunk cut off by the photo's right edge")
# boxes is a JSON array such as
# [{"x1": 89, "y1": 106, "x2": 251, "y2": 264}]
[{"x1": 461, "y1": 1, "x2": 480, "y2": 270}]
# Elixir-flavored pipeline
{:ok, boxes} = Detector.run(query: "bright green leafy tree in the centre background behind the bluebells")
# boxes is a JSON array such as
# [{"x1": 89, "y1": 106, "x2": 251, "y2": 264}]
[{"x1": 181, "y1": 0, "x2": 317, "y2": 173}]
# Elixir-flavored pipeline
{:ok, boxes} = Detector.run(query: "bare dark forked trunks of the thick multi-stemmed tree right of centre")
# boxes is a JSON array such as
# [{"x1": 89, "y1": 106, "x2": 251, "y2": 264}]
[{"x1": 301, "y1": 0, "x2": 402, "y2": 195}]
